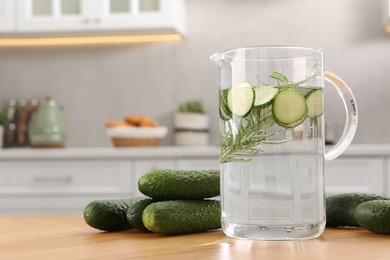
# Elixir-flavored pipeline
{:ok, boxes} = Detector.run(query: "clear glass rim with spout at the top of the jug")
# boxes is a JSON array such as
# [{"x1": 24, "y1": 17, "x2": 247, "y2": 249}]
[{"x1": 210, "y1": 45, "x2": 324, "y2": 63}]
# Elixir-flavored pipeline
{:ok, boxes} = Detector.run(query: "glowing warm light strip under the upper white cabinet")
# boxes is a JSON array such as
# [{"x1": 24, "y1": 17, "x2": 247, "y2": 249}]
[{"x1": 0, "y1": 34, "x2": 182, "y2": 47}]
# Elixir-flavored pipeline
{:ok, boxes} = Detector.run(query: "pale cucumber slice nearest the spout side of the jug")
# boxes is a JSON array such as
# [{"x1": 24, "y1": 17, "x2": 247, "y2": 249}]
[{"x1": 227, "y1": 82, "x2": 255, "y2": 117}]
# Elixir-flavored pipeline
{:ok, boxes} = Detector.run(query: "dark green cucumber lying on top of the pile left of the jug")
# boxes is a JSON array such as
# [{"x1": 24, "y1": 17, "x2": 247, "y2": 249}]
[{"x1": 138, "y1": 169, "x2": 220, "y2": 200}]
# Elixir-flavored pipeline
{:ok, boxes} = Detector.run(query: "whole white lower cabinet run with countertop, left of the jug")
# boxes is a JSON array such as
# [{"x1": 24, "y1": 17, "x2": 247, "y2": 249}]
[{"x1": 0, "y1": 147, "x2": 218, "y2": 215}]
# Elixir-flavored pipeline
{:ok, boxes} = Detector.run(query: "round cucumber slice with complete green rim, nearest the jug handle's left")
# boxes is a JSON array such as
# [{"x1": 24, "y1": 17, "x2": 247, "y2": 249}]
[{"x1": 272, "y1": 88, "x2": 307, "y2": 128}]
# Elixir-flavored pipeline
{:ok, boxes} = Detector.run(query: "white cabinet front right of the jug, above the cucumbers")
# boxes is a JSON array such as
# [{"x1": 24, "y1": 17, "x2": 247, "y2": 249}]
[{"x1": 325, "y1": 156, "x2": 387, "y2": 195}]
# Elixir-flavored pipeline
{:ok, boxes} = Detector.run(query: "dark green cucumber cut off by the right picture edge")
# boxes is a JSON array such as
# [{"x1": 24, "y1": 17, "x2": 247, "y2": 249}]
[{"x1": 355, "y1": 200, "x2": 390, "y2": 234}]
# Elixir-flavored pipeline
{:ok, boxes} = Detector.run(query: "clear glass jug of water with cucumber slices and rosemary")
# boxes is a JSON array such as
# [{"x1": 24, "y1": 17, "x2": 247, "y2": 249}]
[{"x1": 210, "y1": 46, "x2": 358, "y2": 240}]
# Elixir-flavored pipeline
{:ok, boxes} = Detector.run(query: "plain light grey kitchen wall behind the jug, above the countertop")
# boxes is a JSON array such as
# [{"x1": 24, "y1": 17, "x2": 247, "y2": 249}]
[{"x1": 0, "y1": 0, "x2": 390, "y2": 146}]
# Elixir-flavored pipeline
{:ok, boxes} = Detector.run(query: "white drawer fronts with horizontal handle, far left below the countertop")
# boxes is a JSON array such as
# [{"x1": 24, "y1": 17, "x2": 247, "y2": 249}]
[{"x1": 0, "y1": 159, "x2": 135, "y2": 215}]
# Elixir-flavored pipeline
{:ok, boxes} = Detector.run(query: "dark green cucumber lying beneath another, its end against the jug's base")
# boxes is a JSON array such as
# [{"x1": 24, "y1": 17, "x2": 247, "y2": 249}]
[{"x1": 142, "y1": 200, "x2": 221, "y2": 235}]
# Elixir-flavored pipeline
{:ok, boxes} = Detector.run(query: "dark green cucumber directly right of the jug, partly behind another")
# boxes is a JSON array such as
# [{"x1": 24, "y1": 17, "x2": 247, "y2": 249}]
[{"x1": 326, "y1": 193, "x2": 386, "y2": 227}]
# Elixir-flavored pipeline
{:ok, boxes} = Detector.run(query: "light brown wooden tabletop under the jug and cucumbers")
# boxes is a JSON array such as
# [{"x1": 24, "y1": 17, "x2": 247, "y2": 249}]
[{"x1": 0, "y1": 217, "x2": 390, "y2": 260}]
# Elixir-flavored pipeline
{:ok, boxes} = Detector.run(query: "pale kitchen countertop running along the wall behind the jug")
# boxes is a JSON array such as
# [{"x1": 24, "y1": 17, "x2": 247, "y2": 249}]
[{"x1": 0, "y1": 144, "x2": 390, "y2": 160}]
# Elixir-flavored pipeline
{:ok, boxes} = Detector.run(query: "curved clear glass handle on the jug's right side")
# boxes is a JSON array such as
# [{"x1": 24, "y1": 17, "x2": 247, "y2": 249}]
[{"x1": 324, "y1": 69, "x2": 358, "y2": 161}]
